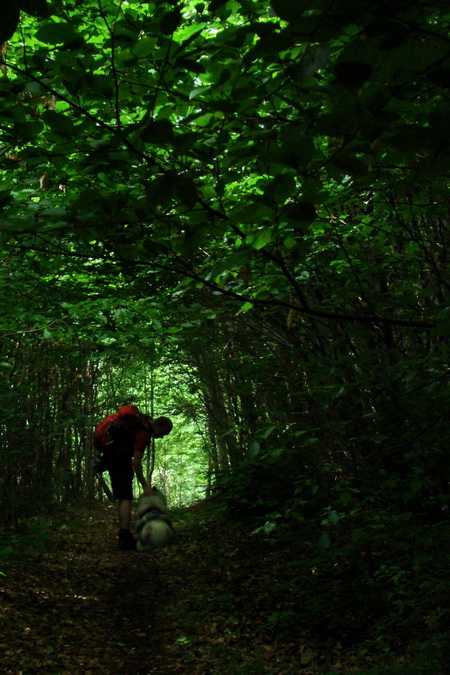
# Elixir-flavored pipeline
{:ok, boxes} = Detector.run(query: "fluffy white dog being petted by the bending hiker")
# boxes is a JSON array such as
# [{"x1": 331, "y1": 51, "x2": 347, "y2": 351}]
[{"x1": 136, "y1": 488, "x2": 175, "y2": 551}]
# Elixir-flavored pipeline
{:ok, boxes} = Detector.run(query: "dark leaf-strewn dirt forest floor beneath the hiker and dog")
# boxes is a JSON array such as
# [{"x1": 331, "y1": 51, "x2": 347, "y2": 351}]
[{"x1": 0, "y1": 504, "x2": 444, "y2": 675}]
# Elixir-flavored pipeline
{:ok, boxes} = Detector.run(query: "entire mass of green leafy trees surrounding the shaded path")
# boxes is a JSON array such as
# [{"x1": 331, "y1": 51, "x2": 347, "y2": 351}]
[{"x1": 0, "y1": 0, "x2": 450, "y2": 667}]
